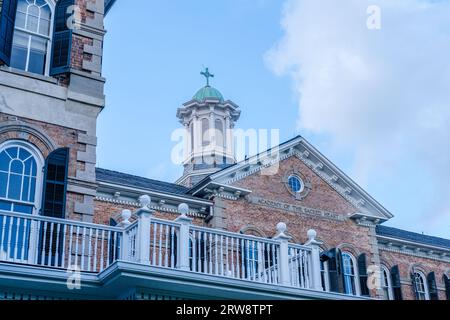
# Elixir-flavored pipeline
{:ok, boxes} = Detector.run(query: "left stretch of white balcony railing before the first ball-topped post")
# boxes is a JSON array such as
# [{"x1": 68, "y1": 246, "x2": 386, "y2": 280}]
[{"x1": 0, "y1": 211, "x2": 123, "y2": 272}]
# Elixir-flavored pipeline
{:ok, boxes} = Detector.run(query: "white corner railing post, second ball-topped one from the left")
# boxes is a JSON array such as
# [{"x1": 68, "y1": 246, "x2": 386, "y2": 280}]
[{"x1": 136, "y1": 195, "x2": 154, "y2": 264}]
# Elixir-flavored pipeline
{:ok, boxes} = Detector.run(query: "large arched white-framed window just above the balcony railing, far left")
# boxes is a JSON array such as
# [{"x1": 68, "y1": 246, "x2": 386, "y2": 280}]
[{"x1": 0, "y1": 143, "x2": 42, "y2": 214}]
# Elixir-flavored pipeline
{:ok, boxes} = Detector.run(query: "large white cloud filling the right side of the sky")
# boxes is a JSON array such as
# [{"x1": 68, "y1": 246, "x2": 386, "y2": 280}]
[{"x1": 266, "y1": 0, "x2": 450, "y2": 230}]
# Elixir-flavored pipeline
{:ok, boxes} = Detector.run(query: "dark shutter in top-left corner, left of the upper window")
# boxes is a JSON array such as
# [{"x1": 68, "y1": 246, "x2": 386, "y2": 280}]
[{"x1": 0, "y1": 0, "x2": 17, "y2": 65}]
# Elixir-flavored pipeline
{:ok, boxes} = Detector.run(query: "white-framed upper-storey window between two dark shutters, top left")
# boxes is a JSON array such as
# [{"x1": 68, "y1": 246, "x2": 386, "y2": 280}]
[{"x1": 11, "y1": 0, "x2": 53, "y2": 74}]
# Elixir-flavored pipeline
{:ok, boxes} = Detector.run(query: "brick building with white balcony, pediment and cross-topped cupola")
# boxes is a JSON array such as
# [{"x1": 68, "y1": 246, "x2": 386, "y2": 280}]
[{"x1": 0, "y1": 0, "x2": 450, "y2": 300}]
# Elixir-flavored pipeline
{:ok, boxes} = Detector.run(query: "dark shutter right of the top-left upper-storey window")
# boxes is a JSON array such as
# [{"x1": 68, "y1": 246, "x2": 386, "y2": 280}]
[{"x1": 50, "y1": 0, "x2": 75, "y2": 75}]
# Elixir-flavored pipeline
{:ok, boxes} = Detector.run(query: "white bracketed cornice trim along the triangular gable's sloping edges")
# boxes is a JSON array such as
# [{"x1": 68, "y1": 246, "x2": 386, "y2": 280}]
[{"x1": 190, "y1": 136, "x2": 393, "y2": 223}]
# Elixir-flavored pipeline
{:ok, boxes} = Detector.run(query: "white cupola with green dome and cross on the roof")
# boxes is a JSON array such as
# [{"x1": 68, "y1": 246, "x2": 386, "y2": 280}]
[{"x1": 177, "y1": 68, "x2": 241, "y2": 187}]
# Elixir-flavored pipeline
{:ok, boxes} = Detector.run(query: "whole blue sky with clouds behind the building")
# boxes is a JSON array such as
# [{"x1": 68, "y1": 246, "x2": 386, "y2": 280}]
[{"x1": 98, "y1": 0, "x2": 450, "y2": 238}]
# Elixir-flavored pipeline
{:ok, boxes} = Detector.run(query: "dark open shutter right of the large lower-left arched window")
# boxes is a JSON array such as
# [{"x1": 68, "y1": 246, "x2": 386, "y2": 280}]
[{"x1": 41, "y1": 148, "x2": 69, "y2": 218}]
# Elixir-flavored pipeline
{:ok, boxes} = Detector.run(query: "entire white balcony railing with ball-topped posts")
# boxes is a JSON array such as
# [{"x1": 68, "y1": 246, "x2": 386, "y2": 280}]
[{"x1": 0, "y1": 199, "x2": 322, "y2": 291}]
